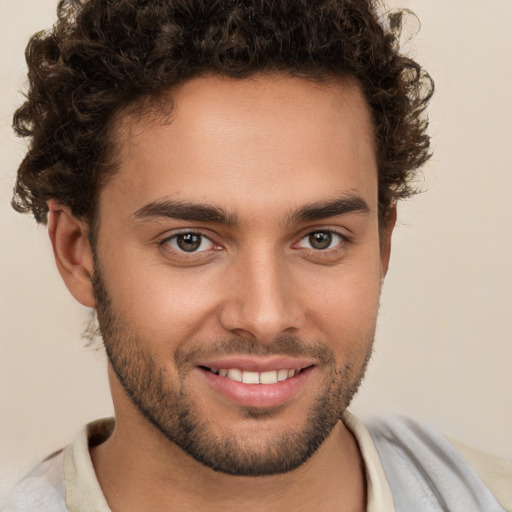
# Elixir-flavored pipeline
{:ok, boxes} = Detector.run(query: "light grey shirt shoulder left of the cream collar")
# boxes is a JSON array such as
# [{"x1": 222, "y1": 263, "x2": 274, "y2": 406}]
[{"x1": 2, "y1": 451, "x2": 67, "y2": 512}]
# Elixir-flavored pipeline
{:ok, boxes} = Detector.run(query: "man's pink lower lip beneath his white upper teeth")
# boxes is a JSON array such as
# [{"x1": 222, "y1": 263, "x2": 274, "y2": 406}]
[{"x1": 198, "y1": 366, "x2": 313, "y2": 408}]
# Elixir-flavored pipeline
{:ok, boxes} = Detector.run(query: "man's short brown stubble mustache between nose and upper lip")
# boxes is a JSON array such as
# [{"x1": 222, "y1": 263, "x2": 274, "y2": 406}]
[{"x1": 175, "y1": 335, "x2": 335, "y2": 367}]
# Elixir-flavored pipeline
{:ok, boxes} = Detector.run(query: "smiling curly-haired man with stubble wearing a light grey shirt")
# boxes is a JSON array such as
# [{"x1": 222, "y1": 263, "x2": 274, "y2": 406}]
[{"x1": 7, "y1": 0, "x2": 512, "y2": 512}]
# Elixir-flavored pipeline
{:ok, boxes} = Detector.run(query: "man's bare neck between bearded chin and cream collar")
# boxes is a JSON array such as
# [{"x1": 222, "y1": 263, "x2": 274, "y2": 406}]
[{"x1": 91, "y1": 414, "x2": 365, "y2": 512}]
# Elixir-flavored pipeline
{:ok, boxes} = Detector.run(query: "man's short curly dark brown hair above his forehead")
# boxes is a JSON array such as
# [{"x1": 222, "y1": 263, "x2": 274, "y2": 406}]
[{"x1": 12, "y1": 0, "x2": 433, "y2": 226}]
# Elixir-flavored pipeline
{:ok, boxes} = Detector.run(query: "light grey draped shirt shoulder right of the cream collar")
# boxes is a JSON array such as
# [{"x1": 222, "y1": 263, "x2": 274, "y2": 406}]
[{"x1": 367, "y1": 417, "x2": 512, "y2": 512}]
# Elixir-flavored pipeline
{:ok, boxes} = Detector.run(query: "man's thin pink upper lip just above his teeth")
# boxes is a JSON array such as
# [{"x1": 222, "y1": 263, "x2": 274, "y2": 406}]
[{"x1": 197, "y1": 356, "x2": 316, "y2": 373}]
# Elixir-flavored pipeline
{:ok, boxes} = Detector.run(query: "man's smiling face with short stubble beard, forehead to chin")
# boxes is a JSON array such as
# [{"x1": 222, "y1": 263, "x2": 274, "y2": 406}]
[{"x1": 94, "y1": 76, "x2": 391, "y2": 475}]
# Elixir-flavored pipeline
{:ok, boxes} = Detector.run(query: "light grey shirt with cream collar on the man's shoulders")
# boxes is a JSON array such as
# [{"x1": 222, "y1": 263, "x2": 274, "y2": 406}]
[{"x1": 5, "y1": 412, "x2": 512, "y2": 512}]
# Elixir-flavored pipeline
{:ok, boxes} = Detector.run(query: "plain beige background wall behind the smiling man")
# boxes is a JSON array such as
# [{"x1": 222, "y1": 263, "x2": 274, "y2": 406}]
[{"x1": 0, "y1": 0, "x2": 512, "y2": 496}]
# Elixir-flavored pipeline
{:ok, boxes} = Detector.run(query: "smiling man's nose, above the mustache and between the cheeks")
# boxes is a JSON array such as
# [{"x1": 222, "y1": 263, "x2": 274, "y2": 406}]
[{"x1": 220, "y1": 249, "x2": 305, "y2": 344}]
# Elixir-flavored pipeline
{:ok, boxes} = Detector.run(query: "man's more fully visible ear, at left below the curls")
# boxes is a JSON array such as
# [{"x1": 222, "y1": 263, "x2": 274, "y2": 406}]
[{"x1": 48, "y1": 201, "x2": 96, "y2": 308}]
